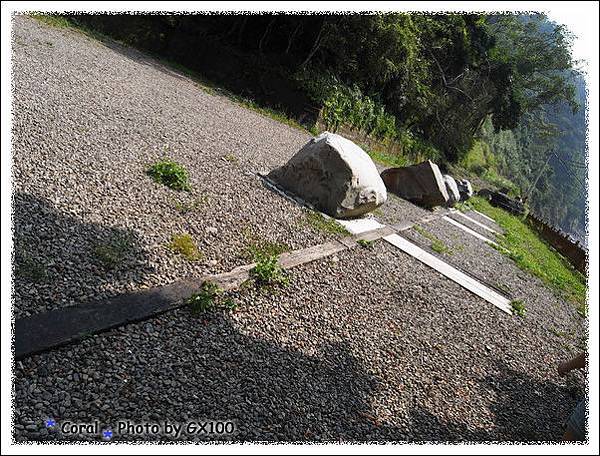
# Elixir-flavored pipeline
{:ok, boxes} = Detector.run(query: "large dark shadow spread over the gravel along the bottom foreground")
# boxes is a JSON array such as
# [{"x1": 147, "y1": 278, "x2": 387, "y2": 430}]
[{"x1": 15, "y1": 309, "x2": 575, "y2": 442}]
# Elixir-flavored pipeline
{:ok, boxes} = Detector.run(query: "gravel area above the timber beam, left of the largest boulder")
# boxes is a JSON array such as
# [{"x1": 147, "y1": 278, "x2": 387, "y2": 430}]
[{"x1": 13, "y1": 16, "x2": 331, "y2": 317}]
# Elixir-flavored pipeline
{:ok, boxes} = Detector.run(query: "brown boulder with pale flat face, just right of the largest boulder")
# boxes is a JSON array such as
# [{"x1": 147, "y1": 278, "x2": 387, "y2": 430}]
[{"x1": 381, "y1": 160, "x2": 450, "y2": 207}]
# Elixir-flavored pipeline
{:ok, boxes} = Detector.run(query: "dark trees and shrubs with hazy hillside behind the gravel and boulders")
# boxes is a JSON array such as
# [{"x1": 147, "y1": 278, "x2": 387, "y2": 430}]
[{"x1": 69, "y1": 14, "x2": 587, "y2": 244}]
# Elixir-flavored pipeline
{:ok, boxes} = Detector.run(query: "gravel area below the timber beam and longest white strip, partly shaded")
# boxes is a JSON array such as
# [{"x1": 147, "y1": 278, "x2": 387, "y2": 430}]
[{"x1": 15, "y1": 241, "x2": 582, "y2": 441}]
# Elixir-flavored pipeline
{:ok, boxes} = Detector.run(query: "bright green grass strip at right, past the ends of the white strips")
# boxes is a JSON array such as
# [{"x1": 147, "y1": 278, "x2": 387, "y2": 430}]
[{"x1": 468, "y1": 196, "x2": 587, "y2": 316}]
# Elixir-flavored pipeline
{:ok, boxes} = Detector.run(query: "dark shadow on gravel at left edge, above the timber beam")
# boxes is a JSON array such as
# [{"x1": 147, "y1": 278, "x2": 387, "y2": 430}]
[{"x1": 12, "y1": 192, "x2": 153, "y2": 317}]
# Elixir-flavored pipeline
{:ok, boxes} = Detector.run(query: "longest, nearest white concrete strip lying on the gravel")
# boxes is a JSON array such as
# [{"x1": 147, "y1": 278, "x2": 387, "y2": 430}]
[{"x1": 383, "y1": 234, "x2": 512, "y2": 314}]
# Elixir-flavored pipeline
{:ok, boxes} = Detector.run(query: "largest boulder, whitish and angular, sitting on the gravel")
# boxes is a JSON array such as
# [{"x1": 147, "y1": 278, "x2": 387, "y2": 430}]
[{"x1": 268, "y1": 132, "x2": 387, "y2": 218}]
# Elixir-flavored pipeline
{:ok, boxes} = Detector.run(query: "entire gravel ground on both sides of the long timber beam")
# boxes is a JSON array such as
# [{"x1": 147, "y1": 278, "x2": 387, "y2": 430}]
[{"x1": 13, "y1": 17, "x2": 583, "y2": 441}]
